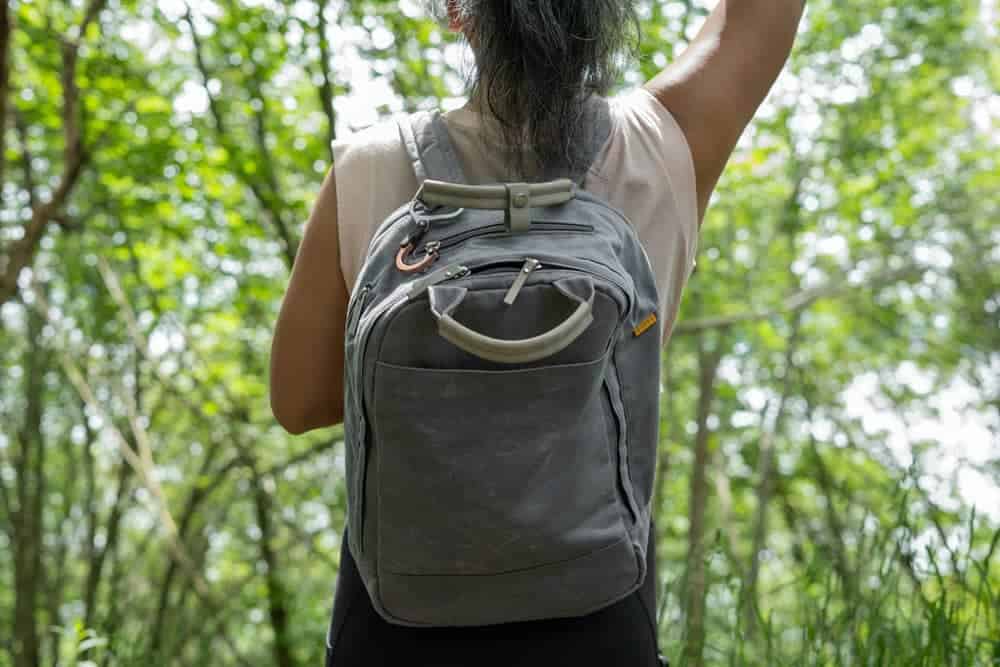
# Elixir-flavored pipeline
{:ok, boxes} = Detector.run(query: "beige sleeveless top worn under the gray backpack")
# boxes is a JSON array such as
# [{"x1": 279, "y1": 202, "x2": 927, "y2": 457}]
[{"x1": 333, "y1": 88, "x2": 699, "y2": 341}]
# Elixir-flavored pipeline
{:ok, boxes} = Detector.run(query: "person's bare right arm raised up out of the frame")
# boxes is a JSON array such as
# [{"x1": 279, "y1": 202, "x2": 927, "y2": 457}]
[{"x1": 646, "y1": 0, "x2": 805, "y2": 220}]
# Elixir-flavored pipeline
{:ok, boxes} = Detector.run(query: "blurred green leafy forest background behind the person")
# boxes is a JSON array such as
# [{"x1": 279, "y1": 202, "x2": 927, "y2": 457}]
[{"x1": 0, "y1": 0, "x2": 1000, "y2": 667}]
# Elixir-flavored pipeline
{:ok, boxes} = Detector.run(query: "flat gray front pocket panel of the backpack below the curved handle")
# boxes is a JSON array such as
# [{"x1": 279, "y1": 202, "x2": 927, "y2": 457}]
[{"x1": 372, "y1": 354, "x2": 625, "y2": 575}]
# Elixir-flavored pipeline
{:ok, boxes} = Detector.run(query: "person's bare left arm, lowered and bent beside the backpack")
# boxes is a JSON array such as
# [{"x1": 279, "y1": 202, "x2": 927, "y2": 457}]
[{"x1": 271, "y1": 168, "x2": 350, "y2": 434}]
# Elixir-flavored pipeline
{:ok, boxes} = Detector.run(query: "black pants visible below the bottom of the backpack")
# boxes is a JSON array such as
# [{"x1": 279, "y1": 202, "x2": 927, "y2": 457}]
[{"x1": 326, "y1": 529, "x2": 660, "y2": 667}]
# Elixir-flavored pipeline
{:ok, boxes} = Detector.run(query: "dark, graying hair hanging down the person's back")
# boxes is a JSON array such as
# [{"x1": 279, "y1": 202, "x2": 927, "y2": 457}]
[{"x1": 440, "y1": 0, "x2": 639, "y2": 177}]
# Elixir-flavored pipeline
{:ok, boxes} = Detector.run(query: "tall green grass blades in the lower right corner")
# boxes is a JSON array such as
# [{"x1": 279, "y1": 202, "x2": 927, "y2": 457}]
[{"x1": 660, "y1": 500, "x2": 1000, "y2": 667}]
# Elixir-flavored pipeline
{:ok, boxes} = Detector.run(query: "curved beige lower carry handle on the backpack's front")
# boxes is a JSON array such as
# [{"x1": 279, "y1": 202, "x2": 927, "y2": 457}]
[{"x1": 428, "y1": 278, "x2": 594, "y2": 364}]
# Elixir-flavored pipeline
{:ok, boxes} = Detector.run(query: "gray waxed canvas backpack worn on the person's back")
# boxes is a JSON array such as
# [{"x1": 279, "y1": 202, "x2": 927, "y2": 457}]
[{"x1": 344, "y1": 103, "x2": 661, "y2": 626}]
